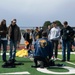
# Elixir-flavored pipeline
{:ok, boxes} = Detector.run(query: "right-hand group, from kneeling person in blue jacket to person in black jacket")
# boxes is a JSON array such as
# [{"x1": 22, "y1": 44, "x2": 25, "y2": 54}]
[{"x1": 32, "y1": 21, "x2": 75, "y2": 67}]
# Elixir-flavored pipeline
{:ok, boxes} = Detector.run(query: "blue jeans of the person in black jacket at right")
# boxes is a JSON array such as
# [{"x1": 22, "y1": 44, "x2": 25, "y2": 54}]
[{"x1": 62, "y1": 40, "x2": 71, "y2": 61}]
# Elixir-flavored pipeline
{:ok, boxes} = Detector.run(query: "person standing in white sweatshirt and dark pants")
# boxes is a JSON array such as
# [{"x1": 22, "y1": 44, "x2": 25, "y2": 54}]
[{"x1": 49, "y1": 22, "x2": 60, "y2": 59}]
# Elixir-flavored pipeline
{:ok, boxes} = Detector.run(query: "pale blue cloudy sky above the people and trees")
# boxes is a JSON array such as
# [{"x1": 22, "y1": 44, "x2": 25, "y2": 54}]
[{"x1": 0, "y1": 0, "x2": 75, "y2": 27}]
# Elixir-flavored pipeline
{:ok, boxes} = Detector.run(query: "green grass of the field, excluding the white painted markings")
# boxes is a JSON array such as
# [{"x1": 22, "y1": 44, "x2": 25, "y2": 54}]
[{"x1": 0, "y1": 49, "x2": 75, "y2": 75}]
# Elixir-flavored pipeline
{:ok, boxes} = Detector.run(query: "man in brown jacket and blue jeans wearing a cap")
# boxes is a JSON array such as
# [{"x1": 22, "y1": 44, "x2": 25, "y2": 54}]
[{"x1": 8, "y1": 19, "x2": 21, "y2": 62}]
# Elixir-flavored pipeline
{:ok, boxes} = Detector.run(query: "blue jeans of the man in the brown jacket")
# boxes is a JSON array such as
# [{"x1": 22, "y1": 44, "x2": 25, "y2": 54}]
[{"x1": 9, "y1": 40, "x2": 17, "y2": 60}]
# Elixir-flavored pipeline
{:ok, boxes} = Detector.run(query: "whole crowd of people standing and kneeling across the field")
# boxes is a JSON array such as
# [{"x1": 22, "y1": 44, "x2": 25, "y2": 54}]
[{"x1": 0, "y1": 19, "x2": 75, "y2": 67}]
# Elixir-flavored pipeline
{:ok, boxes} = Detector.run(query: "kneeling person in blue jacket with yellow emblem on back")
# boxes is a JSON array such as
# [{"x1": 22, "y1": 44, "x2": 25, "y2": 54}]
[{"x1": 32, "y1": 31, "x2": 53, "y2": 68}]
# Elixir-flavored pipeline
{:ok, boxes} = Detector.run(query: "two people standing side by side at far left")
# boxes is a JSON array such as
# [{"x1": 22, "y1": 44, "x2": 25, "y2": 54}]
[{"x1": 0, "y1": 19, "x2": 21, "y2": 62}]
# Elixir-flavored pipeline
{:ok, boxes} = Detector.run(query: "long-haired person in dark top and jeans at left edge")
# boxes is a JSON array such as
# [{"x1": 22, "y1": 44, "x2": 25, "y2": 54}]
[{"x1": 0, "y1": 19, "x2": 8, "y2": 62}]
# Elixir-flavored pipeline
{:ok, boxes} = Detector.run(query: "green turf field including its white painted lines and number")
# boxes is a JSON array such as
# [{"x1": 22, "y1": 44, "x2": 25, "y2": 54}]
[{"x1": 0, "y1": 52, "x2": 75, "y2": 75}]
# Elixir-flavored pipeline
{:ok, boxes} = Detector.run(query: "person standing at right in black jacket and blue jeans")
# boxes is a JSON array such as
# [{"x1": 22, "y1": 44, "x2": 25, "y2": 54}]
[{"x1": 61, "y1": 21, "x2": 74, "y2": 61}]
